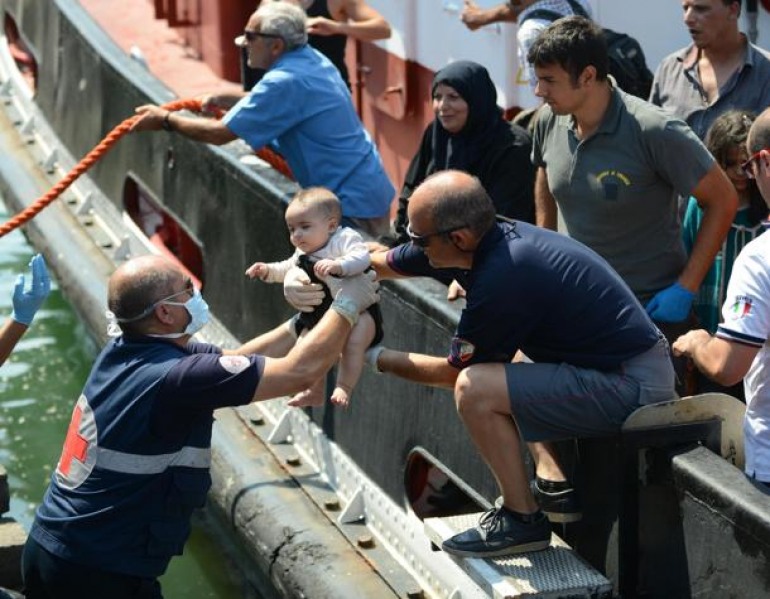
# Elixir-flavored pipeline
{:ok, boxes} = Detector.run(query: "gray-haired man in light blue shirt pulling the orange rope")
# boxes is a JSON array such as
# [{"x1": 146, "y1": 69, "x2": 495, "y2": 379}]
[{"x1": 134, "y1": 2, "x2": 395, "y2": 237}]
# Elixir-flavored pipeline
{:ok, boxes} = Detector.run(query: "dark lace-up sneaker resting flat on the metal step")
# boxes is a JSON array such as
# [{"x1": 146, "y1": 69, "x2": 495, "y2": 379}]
[{"x1": 441, "y1": 508, "x2": 551, "y2": 557}]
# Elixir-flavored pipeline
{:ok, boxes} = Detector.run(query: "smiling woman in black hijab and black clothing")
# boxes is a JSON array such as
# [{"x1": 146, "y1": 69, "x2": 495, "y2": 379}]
[{"x1": 394, "y1": 60, "x2": 535, "y2": 243}]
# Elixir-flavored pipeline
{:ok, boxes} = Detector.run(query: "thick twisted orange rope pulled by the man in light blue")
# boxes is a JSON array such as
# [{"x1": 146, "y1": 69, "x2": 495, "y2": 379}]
[{"x1": 0, "y1": 99, "x2": 293, "y2": 237}]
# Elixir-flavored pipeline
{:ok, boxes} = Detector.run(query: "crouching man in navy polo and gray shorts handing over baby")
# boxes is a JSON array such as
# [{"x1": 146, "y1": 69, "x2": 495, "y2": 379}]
[{"x1": 369, "y1": 171, "x2": 674, "y2": 557}]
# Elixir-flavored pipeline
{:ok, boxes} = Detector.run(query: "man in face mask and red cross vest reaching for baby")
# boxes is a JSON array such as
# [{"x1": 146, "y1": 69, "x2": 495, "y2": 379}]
[{"x1": 23, "y1": 256, "x2": 377, "y2": 599}]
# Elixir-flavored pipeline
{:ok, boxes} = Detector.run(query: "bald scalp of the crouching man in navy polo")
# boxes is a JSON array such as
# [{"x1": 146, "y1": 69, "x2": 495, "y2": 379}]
[{"x1": 409, "y1": 170, "x2": 495, "y2": 239}]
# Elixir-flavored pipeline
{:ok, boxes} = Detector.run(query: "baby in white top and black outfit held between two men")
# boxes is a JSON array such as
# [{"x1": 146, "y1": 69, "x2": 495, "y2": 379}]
[{"x1": 246, "y1": 187, "x2": 382, "y2": 407}]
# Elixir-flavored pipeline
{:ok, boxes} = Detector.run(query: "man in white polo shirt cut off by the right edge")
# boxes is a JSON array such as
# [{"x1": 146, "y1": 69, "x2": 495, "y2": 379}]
[{"x1": 673, "y1": 110, "x2": 770, "y2": 495}]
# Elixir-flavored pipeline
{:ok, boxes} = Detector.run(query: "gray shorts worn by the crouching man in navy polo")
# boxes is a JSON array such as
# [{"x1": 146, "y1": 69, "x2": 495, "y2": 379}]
[{"x1": 505, "y1": 337, "x2": 675, "y2": 441}]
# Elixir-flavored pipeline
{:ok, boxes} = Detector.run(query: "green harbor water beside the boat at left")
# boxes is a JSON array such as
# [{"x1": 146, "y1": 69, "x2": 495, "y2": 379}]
[{"x1": 0, "y1": 203, "x2": 244, "y2": 599}]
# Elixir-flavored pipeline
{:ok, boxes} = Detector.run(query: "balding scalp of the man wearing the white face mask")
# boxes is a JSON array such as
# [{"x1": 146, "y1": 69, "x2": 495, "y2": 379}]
[{"x1": 107, "y1": 255, "x2": 185, "y2": 333}]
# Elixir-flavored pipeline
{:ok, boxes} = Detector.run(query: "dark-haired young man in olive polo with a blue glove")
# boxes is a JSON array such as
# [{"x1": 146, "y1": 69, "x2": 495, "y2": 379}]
[{"x1": 527, "y1": 17, "x2": 737, "y2": 392}]
